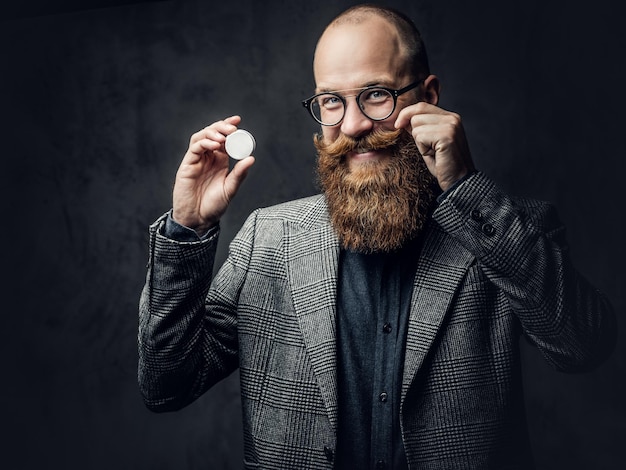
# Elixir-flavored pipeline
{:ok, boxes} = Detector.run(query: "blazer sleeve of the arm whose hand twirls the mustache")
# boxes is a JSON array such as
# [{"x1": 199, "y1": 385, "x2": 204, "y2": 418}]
[{"x1": 434, "y1": 172, "x2": 616, "y2": 372}]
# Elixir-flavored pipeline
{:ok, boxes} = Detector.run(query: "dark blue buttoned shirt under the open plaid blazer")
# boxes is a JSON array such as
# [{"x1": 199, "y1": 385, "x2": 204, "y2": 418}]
[{"x1": 335, "y1": 240, "x2": 420, "y2": 470}]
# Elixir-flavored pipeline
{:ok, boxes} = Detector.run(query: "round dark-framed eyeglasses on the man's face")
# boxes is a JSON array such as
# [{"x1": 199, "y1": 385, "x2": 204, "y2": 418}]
[{"x1": 302, "y1": 79, "x2": 424, "y2": 126}]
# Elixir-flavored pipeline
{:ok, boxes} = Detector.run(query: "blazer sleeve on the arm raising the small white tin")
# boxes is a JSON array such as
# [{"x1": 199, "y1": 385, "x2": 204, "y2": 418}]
[{"x1": 138, "y1": 210, "x2": 253, "y2": 411}]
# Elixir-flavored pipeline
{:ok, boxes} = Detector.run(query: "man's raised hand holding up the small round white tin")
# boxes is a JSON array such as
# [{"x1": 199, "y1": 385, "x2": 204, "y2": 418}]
[{"x1": 172, "y1": 116, "x2": 254, "y2": 235}]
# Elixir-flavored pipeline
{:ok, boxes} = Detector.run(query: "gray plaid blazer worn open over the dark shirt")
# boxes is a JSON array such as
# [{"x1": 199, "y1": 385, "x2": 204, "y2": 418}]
[{"x1": 139, "y1": 173, "x2": 613, "y2": 470}]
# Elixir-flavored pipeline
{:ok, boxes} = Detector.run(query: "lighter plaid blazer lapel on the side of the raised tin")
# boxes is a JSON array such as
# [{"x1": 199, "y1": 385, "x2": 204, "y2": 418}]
[{"x1": 285, "y1": 199, "x2": 339, "y2": 431}]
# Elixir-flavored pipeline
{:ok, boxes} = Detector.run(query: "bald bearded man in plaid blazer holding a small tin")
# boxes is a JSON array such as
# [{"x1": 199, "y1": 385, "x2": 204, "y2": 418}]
[{"x1": 139, "y1": 5, "x2": 614, "y2": 470}]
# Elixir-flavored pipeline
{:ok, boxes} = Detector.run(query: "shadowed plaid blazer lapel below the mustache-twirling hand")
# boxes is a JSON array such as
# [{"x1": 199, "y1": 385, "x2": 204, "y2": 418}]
[{"x1": 402, "y1": 221, "x2": 474, "y2": 401}]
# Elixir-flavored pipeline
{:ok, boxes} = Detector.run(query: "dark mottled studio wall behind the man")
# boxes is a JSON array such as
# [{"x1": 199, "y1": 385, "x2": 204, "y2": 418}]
[{"x1": 0, "y1": 0, "x2": 626, "y2": 470}]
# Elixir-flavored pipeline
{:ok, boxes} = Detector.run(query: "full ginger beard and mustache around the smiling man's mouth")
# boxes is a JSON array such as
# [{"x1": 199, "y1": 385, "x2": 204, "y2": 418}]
[{"x1": 314, "y1": 129, "x2": 440, "y2": 253}]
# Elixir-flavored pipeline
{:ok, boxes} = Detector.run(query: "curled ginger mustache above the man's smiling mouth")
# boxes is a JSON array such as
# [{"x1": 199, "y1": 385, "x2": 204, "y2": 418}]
[{"x1": 313, "y1": 129, "x2": 406, "y2": 158}]
